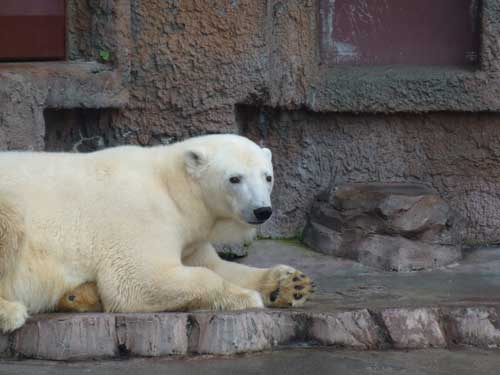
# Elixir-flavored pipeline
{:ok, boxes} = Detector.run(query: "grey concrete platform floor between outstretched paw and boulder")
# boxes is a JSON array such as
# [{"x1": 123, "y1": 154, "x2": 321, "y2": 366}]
[{"x1": 240, "y1": 241, "x2": 500, "y2": 311}]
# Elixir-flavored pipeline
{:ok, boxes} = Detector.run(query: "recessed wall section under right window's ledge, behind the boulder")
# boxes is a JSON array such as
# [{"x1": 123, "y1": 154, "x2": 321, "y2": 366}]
[{"x1": 237, "y1": 106, "x2": 500, "y2": 242}]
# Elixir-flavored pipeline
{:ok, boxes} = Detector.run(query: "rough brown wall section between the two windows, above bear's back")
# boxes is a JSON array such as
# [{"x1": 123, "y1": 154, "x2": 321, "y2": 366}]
[{"x1": 109, "y1": 0, "x2": 268, "y2": 144}]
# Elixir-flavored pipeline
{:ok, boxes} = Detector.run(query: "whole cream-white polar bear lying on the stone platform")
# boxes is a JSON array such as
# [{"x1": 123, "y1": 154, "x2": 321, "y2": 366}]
[{"x1": 0, "y1": 135, "x2": 313, "y2": 331}]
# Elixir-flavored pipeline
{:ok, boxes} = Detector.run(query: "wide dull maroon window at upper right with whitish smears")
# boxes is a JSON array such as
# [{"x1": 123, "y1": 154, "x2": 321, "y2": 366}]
[{"x1": 320, "y1": 0, "x2": 480, "y2": 66}]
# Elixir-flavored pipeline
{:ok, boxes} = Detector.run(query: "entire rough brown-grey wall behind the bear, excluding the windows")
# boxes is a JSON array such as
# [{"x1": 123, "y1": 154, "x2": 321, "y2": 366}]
[{"x1": 0, "y1": 0, "x2": 500, "y2": 241}]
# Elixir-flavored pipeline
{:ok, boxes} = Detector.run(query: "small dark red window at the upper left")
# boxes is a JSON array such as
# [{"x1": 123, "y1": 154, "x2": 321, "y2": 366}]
[{"x1": 0, "y1": 0, "x2": 66, "y2": 61}]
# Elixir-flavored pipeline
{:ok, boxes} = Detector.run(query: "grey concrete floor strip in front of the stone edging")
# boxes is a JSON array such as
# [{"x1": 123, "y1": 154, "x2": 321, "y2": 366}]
[{"x1": 0, "y1": 348, "x2": 500, "y2": 375}]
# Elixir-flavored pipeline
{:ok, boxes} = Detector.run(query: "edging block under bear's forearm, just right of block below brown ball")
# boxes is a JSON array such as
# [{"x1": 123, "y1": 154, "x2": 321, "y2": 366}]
[{"x1": 116, "y1": 313, "x2": 189, "y2": 357}]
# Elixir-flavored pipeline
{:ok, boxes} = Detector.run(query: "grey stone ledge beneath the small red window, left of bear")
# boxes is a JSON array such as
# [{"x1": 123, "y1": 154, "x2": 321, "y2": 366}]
[{"x1": 0, "y1": 62, "x2": 129, "y2": 151}]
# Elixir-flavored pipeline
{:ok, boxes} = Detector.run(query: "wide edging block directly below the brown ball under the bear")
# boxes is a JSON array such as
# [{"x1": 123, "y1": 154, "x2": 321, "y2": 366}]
[{"x1": 13, "y1": 314, "x2": 118, "y2": 360}]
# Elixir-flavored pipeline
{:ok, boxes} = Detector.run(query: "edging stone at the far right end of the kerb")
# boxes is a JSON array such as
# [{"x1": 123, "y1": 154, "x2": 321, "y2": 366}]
[{"x1": 447, "y1": 307, "x2": 500, "y2": 348}]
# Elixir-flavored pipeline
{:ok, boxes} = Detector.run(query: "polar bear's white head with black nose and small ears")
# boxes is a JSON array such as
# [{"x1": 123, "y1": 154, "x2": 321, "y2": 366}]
[{"x1": 185, "y1": 135, "x2": 274, "y2": 225}]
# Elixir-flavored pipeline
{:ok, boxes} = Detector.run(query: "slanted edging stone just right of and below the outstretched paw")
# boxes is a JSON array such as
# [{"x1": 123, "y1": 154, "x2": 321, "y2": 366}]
[{"x1": 309, "y1": 309, "x2": 385, "y2": 350}]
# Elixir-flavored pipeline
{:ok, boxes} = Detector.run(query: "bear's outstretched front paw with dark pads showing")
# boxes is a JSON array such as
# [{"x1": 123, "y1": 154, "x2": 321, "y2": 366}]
[{"x1": 259, "y1": 265, "x2": 314, "y2": 307}]
